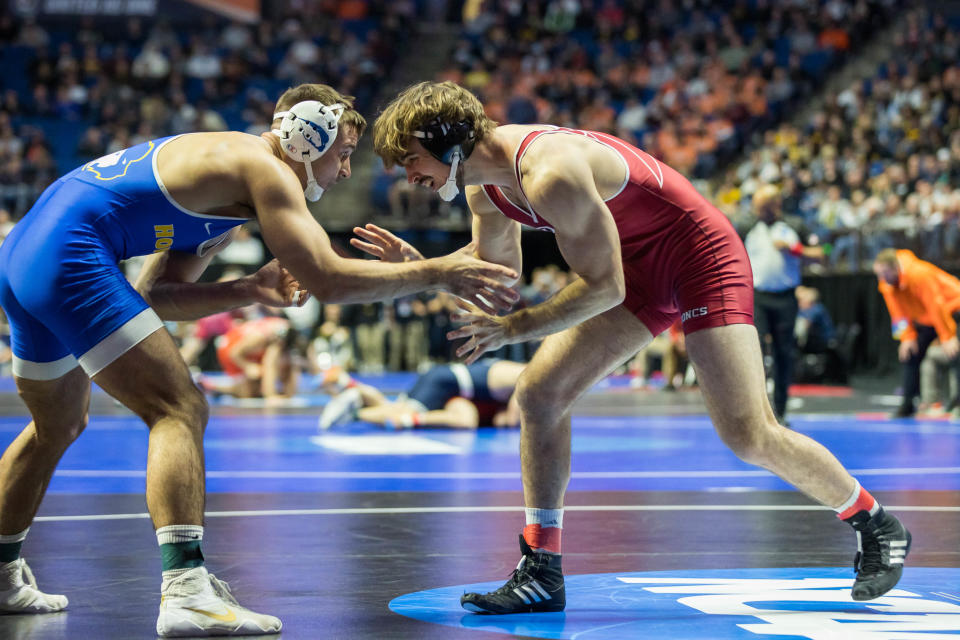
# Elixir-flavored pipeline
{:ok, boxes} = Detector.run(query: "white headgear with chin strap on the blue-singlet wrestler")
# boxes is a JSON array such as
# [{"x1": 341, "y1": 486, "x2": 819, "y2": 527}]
[{"x1": 273, "y1": 100, "x2": 346, "y2": 202}]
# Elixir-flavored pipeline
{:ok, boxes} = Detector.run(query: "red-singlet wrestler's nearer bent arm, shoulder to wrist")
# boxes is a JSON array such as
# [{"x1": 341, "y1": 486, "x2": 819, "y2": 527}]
[{"x1": 498, "y1": 146, "x2": 626, "y2": 342}]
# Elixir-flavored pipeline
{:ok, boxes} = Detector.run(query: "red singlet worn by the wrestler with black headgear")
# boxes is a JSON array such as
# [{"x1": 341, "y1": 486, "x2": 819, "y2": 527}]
[{"x1": 483, "y1": 127, "x2": 753, "y2": 335}]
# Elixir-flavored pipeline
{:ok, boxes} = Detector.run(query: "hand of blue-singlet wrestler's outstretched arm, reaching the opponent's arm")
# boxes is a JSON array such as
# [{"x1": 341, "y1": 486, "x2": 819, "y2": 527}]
[{"x1": 436, "y1": 242, "x2": 520, "y2": 313}]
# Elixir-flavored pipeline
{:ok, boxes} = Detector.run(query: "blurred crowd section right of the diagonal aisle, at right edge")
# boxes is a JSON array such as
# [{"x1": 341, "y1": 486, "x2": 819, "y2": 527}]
[{"x1": 712, "y1": 10, "x2": 960, "y2": 270}]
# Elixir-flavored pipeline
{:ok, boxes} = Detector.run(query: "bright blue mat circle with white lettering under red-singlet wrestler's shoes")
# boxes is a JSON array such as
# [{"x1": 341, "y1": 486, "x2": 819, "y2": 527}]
[{"x1": 390, "y1": 567, "x2": 960, "y2": 640}]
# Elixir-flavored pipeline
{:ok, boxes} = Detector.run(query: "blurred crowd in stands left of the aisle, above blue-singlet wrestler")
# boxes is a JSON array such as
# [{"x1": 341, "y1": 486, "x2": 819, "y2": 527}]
[{"x1": 0, "y1": 0, "x2": 423, "y2": 219}]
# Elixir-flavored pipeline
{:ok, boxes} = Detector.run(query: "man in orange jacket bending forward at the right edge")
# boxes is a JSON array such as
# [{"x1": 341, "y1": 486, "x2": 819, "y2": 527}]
[{"x1": 873, "y1": 249, "x2": 960, "y2": 418}]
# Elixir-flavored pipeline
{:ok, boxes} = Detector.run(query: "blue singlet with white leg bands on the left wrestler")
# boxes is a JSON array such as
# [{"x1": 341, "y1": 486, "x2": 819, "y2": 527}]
[{"x1": 0, "y1": 138, "x2": 246, "y2": 380}]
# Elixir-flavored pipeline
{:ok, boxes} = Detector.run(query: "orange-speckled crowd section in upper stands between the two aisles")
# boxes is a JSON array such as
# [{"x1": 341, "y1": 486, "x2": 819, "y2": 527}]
[{"x1": 441, "y1": 0, "x2": 895, "y2": 177}]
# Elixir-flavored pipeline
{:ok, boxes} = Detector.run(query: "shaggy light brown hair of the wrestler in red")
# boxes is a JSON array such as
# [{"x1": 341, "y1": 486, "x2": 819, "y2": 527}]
[{"x1": 373, "y1": 81, "x2": 497, "y2": 168}]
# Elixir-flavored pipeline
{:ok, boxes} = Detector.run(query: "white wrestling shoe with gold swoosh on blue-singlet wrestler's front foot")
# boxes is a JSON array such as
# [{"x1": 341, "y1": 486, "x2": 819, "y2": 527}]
[{"x1": 157, "y1": 567, "x2": 283, "y2": 638}]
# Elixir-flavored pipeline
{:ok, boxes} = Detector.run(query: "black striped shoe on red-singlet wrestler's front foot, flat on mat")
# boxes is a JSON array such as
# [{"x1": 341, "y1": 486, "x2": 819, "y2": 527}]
[{"x1": 460, "y1": 535, "x2": 567, "y2": 614}]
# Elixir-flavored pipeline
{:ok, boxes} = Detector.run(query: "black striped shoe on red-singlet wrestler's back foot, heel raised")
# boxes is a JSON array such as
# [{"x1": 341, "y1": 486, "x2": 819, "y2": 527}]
[{"x1": 847, "y1": 507, "x2": 911, "y2": 600}]
